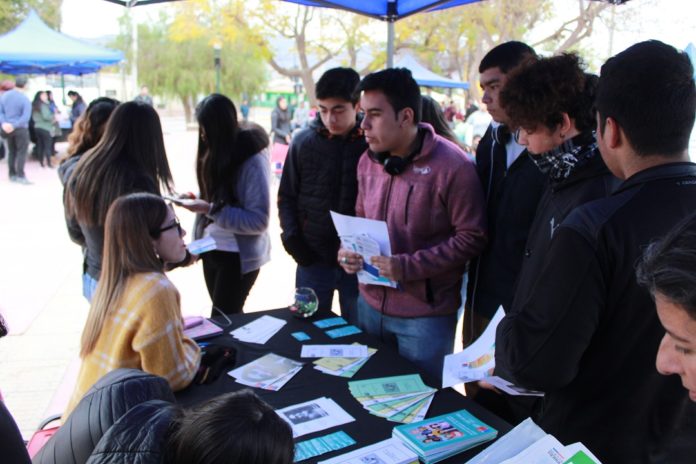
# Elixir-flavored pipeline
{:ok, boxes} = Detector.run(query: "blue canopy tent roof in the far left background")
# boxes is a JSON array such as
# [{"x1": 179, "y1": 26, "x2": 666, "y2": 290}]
[{"x1": 0, "y1": 11, "x2": 123, "y2": 74}]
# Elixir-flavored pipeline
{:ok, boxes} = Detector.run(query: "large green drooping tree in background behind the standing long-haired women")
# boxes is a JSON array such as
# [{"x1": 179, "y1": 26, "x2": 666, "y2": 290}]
[{"x1": 113, "y1": 0, "x2": 266, "y2": 122}]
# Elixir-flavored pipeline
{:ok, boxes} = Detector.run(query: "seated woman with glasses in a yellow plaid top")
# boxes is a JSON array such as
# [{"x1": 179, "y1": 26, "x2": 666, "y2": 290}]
[{"x1": 64, "y1": 193, "x2": 200, "y2": 417}]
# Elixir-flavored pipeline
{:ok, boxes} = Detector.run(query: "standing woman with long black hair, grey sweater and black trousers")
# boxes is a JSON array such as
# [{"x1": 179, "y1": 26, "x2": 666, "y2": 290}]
[{"x1": 177, "y1": 94, "x2": 271, "y2": 315}]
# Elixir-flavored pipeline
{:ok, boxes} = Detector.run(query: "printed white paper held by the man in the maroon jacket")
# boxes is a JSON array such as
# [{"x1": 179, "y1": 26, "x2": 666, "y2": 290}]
[{"x1": 331, "y1": 211, "x2": 397, "y2": 288}]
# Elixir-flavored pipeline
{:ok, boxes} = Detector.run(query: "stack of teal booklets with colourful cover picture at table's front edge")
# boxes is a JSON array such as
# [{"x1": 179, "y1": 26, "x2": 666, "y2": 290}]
[{"x1": 392, "y1": 409, "x2": 498, "y2": 464}]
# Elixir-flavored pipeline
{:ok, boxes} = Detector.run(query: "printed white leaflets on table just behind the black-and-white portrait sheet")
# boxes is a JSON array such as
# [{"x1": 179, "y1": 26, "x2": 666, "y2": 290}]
[{"x1": 227, "y1": 353, "x2": 304, "y2": 391}]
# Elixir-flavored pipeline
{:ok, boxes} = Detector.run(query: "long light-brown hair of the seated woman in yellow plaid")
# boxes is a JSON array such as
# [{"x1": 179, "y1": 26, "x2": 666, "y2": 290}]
[{"x1": 80, "y1": 193, "x2": 168, "y2": 358}]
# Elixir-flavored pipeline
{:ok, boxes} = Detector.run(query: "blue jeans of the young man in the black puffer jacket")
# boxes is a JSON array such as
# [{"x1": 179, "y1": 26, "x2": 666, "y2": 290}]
[{"x1": 295, "y1": 264, "x2": 358, "y2": 324}]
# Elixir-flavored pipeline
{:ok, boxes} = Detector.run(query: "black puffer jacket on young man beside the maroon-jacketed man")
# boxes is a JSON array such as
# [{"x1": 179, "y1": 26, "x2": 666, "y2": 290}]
[{"x1": 278, "y1": 116, "x2": 367, "y2": 266}]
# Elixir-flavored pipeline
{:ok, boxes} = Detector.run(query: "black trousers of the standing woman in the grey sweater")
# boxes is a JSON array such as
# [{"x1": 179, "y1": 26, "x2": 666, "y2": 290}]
[{"x1": 202, "y1": 250, "x2": 259, "y2": 316}]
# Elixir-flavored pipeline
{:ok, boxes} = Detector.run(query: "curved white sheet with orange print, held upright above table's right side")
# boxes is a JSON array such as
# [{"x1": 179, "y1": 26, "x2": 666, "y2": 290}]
[{"x1": 442, "y1": 306, "x2": 505, "y2": 388}]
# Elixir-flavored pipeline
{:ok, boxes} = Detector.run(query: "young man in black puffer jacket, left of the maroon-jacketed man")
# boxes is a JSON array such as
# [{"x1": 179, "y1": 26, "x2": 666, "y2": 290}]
[{"x1": 278, "y1": 68, "x2": 367, "y2": 322}]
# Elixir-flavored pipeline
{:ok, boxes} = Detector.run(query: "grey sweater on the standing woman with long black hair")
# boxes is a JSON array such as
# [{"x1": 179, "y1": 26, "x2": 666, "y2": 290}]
[{"x1": 203, "y1": 149, "x2": 271, "y2": 274}]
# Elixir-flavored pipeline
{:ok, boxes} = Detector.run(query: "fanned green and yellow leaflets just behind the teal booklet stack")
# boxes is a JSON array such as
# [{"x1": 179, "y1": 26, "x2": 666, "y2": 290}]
[{"x1": 348, "y1": 374, "x2": 437, "y2": 423}]
